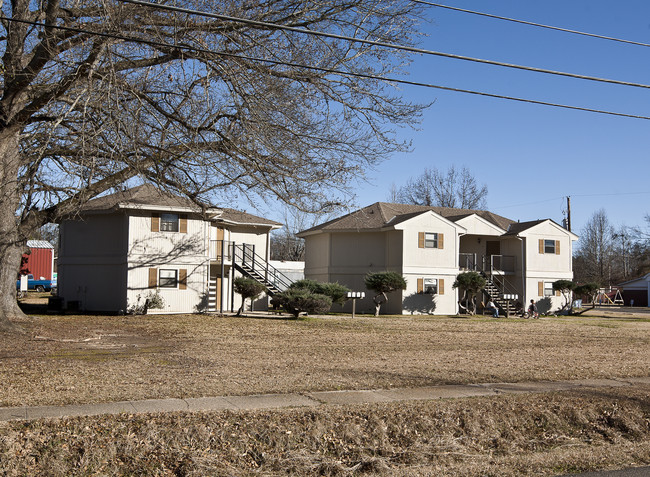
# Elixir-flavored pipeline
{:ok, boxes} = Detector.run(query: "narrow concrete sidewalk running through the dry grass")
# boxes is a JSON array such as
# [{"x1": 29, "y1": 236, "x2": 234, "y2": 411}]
[{"x1": 0, "y1": 377, "x2": 650, "y2": 421}]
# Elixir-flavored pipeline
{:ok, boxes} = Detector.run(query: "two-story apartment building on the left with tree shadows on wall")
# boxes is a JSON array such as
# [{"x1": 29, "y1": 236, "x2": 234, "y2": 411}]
[{"x1": 58, "y1": 184, "x2": 280, "y2": 313}]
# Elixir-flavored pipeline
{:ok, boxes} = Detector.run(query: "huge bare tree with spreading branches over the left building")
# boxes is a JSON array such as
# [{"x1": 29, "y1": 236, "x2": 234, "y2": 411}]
[{"x1": 0, "y1": 0, "x2": 423, "y2": 329}]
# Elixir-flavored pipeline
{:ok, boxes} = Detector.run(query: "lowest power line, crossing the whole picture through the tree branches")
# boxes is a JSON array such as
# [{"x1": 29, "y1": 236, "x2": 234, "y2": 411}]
[{"x1": 0, "y1": 16, "x2": 650, "y2": 120}]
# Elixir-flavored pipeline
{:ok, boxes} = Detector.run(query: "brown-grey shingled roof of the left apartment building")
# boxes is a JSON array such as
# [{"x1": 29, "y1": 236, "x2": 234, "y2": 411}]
[{"x1": 82, "y1": 184, "x2": 282, "y2": 226}]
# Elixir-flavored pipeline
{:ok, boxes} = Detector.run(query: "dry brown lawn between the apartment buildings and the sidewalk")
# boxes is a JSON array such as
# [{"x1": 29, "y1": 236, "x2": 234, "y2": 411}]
[{"x1": 0, "y1": 315, "x2": 650, "y2": 406}]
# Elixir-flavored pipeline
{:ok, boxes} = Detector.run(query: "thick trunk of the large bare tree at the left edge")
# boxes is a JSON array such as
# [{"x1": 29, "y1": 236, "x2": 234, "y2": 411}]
[{"x1": 0, "y1": 128, "x2": 25, "y2": 332}]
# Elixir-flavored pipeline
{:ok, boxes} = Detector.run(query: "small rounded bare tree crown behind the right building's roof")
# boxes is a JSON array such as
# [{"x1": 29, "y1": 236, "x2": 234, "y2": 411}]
[{"x1": 397, "y1": 166, "x2": 488, "y2": 209}]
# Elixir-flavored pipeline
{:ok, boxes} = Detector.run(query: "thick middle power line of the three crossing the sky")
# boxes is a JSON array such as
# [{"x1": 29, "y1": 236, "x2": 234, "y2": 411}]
[{"x1": 119, "y1": 0, "x2": 650, "y2": 89}]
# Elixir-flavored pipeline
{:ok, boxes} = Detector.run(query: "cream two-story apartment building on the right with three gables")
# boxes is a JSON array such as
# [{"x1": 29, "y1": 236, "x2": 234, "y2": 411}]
[{"x1": 299, "y1": 202, "x2": 577, "y2": 314}]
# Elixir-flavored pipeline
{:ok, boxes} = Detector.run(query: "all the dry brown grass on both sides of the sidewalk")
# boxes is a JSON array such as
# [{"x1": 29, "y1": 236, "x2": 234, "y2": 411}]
[{"x1": 0, "y1": 306, "x2": 650, "y2": 476}]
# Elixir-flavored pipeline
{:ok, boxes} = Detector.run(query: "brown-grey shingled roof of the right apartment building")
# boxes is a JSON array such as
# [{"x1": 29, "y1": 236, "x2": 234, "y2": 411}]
[{"x1": 301, "y1": 202, "x2": 515, "y2": 234}]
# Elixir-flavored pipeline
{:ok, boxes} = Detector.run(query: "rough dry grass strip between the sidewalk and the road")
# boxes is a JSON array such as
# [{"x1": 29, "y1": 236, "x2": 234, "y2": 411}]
[{"x1": 0, "y1": 386, "x2": 650, "y2": 477}]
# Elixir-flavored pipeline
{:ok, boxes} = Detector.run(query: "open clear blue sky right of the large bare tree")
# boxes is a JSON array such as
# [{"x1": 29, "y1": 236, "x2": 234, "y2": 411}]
[{"x1": 256, "y1": 0, "x2": 650, "y2": 234}]
